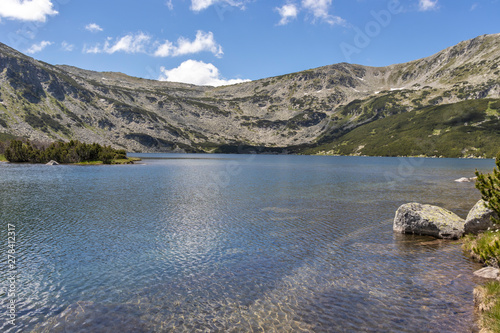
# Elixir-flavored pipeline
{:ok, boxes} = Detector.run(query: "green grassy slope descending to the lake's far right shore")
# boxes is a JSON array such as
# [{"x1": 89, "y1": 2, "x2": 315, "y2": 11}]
[{"x1": 304, "y1": 99, "x2": 500, "y2": 158}]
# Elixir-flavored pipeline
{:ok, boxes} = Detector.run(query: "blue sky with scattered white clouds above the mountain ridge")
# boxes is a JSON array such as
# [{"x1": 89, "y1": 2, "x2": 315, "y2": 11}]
[{"x1": 0, "y1": 0, "x2": 500, "y2": 85}]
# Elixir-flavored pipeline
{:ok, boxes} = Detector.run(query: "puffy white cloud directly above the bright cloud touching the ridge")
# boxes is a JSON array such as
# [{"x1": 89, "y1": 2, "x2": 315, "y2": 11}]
[{"x1": 154, "y1": 30, "x2": 223, "y2": 58}]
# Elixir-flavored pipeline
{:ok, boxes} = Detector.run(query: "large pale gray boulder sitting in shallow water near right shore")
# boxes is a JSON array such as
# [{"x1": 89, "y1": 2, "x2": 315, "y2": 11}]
[{"x1": 393, "y1": 202, "x2": 465, "y2": 239}]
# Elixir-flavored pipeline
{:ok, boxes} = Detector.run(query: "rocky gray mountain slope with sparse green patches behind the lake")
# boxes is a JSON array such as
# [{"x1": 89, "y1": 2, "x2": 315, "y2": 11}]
[{"x1": 0, "y1": 34, "x2": 500, "y2": 153}]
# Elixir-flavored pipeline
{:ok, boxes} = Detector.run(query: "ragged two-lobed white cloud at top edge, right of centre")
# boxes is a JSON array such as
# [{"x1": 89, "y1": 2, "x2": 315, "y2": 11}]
[{"x1": 276, "y1": 0, "x2": 345, "y2": 25}]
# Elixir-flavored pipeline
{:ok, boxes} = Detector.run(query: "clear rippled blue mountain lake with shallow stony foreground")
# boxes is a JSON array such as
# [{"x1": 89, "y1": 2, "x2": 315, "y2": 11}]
[{"x1": 0, "y1": 154, "x2": 494, "y2": 332}]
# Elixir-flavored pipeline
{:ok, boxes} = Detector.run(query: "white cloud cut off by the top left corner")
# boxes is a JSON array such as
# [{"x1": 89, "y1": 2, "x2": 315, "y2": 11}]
[{"x1": 0, "y1": 0, "x2": 58, "y2": 22}]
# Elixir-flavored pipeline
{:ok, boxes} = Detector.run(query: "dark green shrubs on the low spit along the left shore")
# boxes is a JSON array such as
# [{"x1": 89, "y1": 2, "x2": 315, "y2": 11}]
[{"x1": 5, "y1": 140, "x2": 127, "y2": 164}]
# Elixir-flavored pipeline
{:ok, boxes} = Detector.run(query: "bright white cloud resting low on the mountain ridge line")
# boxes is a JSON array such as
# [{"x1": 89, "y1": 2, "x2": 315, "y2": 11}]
[{"x1": 158, "y1": 60, "x2": 250, "y2": 87}]
